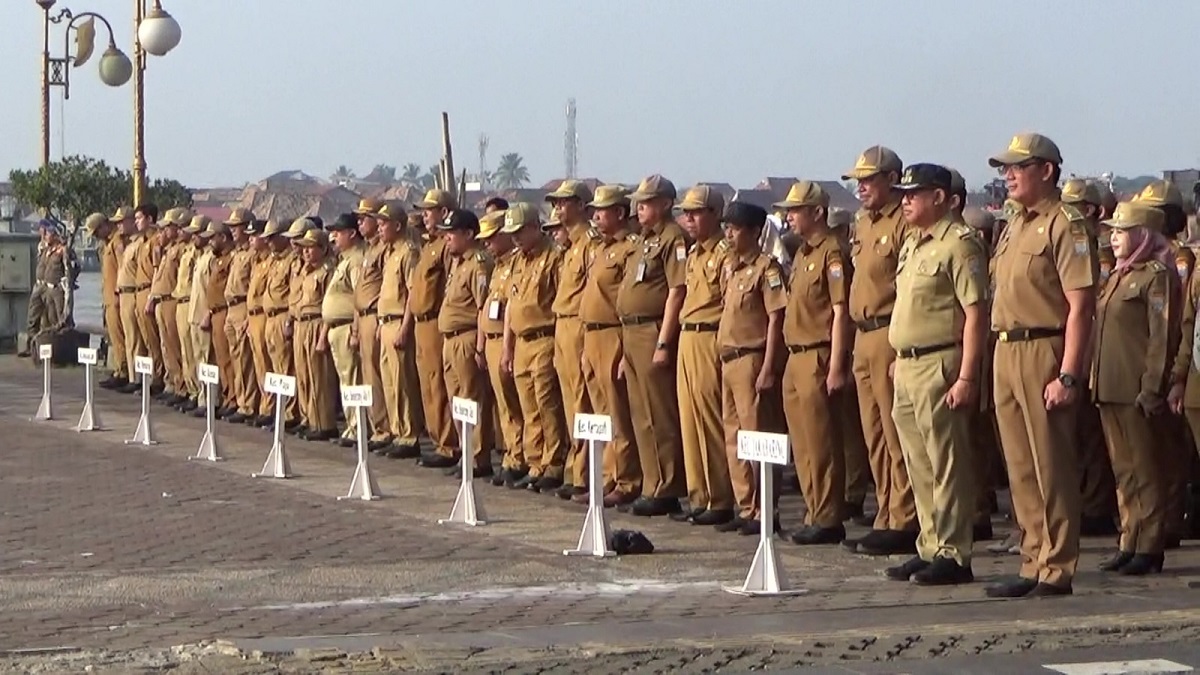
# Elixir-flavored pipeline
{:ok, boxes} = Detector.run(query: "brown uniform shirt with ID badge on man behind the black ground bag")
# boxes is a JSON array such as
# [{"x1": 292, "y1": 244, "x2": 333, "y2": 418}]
[{"x1": 617, "y1": 221, "x2": 688, "y2": 317}]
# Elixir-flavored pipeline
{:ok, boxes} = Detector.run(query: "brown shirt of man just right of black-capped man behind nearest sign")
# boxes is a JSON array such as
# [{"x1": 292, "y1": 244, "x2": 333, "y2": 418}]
[{"x1": 784, "y1": 232, "x2": 851, "y2": 347}]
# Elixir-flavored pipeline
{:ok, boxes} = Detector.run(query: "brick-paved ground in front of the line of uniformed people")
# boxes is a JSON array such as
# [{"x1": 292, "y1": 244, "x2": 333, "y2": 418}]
[{"x1": 0, "y1": 358, "x2": 1200, "y2": 673}]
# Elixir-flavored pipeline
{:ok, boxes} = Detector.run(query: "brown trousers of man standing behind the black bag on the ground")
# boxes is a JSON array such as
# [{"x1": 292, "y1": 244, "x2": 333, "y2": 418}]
[{"x1": 620, "y1": 321, "x2": 688, "y2": 498}]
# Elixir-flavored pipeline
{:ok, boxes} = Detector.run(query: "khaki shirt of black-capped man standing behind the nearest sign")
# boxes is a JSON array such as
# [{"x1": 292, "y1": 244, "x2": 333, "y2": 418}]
[{"x1": 706, "y1": 249, "x2": 787, "y2": 350}]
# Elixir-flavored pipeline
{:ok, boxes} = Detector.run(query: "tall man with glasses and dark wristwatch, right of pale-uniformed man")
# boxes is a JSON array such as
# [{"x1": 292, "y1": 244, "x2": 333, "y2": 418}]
[{"x1": 988, "y1": 133, "x2": 1099, "y2": 597}]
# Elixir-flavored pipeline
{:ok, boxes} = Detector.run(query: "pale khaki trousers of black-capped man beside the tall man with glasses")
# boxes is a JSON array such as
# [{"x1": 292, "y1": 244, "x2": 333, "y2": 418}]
[{"x1": 892, "y1": 348, "x2": 976, "y2": 566}]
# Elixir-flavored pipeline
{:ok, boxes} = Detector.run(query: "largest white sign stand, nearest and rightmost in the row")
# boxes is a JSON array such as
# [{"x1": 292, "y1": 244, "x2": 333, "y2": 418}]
[{"x1": 725, "y1": 429, "x2": 808, "y2": 596}]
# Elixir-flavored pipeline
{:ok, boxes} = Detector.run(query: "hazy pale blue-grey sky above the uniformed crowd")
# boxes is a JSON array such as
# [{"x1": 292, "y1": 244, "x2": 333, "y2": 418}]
[{"x1": 0, "y1": 0, "x2": 1200, "y2": 187}]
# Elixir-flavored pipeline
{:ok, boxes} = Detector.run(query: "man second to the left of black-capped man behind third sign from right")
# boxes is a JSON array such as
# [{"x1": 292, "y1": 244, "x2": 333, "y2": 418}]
[{"x1": 377, "y1": 203, "x2": 425, "y2": 459}]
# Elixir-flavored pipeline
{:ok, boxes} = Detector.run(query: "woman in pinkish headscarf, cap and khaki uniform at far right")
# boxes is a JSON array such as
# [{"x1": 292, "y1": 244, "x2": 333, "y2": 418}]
[{"x1": 1091, "y1": 203, "x2": 1178, "y2": 575}]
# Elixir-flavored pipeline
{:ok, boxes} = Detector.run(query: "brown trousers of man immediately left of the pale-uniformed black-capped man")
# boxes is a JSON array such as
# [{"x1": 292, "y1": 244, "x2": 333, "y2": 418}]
[{"x1": 853, "y1": 327, "x2": 918, "y2": 532}]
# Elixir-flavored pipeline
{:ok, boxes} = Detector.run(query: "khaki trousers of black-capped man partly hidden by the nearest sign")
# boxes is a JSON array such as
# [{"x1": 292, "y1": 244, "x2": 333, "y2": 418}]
[{"x1": 721, "y1": 352, "x2": 784, "y2": 520}]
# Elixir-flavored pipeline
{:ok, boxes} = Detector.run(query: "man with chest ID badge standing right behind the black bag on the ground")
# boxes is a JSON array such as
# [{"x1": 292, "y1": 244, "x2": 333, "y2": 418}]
[{"x1": 617, "y1": 174, "x2": 688, "y2": 516}]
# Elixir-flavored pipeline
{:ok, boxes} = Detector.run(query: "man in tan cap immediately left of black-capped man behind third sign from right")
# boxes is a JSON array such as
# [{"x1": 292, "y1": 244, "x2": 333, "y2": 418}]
[{"x1": 408, "y1": 190, "x2": 458, "y2": 468}]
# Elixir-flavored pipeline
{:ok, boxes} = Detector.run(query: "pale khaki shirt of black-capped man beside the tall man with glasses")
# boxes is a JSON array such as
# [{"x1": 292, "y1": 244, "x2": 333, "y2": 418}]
[{"x1": 888, "y1": 219, "x2": 989, "y2": 351}]
